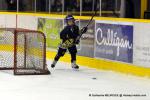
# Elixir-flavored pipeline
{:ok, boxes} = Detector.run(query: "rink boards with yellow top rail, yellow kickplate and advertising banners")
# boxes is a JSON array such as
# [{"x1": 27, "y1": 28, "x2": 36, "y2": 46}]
[{"x1": 0, "y1": 12, "x2": 150, "y2": 76}]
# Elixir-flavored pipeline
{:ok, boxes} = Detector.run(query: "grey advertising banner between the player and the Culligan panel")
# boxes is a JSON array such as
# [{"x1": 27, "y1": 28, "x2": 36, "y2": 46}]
[{"x1": 78, "y1": 20, "x2": 95, "y2": 57}]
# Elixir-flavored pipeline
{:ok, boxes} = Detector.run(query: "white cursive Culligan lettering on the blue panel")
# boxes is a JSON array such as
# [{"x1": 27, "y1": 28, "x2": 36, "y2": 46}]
[{"x1": 95, "y1": 28, "x2": 133, "y2": 56}]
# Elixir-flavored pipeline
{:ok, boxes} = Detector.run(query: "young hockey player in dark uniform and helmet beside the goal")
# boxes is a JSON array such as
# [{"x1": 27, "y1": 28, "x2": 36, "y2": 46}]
[{"x1": 51, "y1": 15, "x2": 87, "y2": 69}]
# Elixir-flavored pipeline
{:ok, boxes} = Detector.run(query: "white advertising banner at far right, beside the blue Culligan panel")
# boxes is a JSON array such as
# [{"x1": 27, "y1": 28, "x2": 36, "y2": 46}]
[{"x1": 133, "y1": 23, "x2": 150, "y2": 68}]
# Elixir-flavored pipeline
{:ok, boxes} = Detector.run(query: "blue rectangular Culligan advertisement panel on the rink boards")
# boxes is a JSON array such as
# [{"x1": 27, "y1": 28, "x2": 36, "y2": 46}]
[{"x1": 94, "y1": 21, "x2": 133, "y2": 63}]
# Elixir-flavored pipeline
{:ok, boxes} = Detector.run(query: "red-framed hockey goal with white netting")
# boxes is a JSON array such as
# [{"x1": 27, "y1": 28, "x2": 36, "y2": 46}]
[{"x1": 0, "y1": 28, "x2": 50, "y2": 75}]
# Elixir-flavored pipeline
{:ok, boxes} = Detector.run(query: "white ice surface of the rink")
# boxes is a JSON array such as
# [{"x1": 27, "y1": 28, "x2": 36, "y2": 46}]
[{"x1": 0, "y1": 61, "x2": 150, "y2": 100}]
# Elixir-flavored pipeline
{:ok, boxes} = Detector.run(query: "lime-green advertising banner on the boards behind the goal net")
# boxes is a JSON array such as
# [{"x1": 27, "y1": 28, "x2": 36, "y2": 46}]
[{"x1": 38, "y1": 18, "x2": 63, "y2": 49}]
